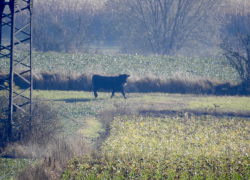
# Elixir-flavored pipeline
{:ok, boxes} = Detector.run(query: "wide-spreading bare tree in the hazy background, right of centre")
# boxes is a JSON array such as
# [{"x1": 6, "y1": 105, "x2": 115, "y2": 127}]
[{"x1": 107, "y1": 0, "x2": 217, "y2": 54}]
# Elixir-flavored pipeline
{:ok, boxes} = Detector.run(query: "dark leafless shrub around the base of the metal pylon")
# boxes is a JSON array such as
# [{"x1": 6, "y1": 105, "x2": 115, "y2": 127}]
[{"x1": 0, "y1": 93, "x2": 60, "y2": 147}]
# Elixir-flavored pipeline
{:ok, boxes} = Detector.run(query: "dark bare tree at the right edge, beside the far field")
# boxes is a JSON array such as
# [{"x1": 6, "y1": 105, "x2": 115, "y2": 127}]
[{"x1": 219, "y1": 12, "x2": 250, "y2": 87}]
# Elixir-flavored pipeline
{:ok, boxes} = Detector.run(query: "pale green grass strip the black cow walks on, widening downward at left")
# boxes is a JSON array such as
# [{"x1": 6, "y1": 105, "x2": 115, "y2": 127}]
[{"x1": 2, "y1": 91, "x2": 250, "y2": 140}]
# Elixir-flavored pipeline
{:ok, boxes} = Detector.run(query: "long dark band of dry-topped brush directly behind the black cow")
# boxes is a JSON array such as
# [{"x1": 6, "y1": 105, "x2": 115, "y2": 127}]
[{"x1": 0, "y1": 72, "x2": 250, "y2": 95}]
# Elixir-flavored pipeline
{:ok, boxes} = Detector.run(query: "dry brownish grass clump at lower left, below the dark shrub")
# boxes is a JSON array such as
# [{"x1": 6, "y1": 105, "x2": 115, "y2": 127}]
[{"x1": 13, "y1": 137, "x2": 89, "y2": 180}]
